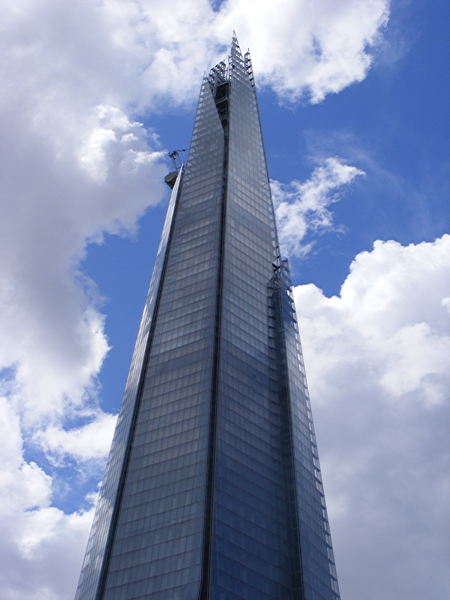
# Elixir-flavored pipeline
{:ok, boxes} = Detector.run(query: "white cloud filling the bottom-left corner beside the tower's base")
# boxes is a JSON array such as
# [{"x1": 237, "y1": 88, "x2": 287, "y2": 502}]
[{"x1": 0, "y1": 398, "x2": 92, "y2": 600}]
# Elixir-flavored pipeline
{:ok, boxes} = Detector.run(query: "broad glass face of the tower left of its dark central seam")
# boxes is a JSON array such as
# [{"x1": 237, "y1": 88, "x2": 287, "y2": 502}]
[{"x1": 100, "y1": 82, "x2": 224, "y2": 600}]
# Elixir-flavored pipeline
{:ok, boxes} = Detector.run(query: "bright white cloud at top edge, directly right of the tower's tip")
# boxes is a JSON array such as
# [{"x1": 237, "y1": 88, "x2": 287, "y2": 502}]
[{"x1": 218, "y1": 0, "x2": 389, "y2": 103}]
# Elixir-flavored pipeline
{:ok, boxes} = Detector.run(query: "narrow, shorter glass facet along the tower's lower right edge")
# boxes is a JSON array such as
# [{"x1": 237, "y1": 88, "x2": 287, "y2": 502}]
[{"x1": 276, "y1": 260, "x2": 339, "y2": 600}]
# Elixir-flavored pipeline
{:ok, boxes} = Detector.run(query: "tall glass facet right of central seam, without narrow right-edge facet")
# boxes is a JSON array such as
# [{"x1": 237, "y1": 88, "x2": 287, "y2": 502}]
[{"x1": 212, "y1": 39, "x2": 293, "y2": 600}]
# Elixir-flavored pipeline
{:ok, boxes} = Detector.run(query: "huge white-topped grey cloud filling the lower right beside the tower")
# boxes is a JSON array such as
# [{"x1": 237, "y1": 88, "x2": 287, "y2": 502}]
[{"x1": 295, "y1": 235, "x2": 450, "y2": 600}]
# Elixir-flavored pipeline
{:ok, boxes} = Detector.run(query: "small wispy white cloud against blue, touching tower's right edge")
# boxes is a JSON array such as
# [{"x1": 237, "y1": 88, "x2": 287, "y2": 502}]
[{"x1": 271, "y1": 157, "x2": 364, "y2": 256}]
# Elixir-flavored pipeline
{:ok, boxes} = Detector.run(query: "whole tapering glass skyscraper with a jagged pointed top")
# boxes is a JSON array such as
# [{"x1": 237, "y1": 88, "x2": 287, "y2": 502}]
[{"x1": 76, "y1": 37, "x2": 339, "y2": 600}]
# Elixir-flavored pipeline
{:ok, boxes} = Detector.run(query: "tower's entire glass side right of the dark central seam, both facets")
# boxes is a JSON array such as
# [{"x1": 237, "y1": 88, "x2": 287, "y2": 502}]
[{"x1": 212, "y1": 38, "x2": 339, "y2": 600}]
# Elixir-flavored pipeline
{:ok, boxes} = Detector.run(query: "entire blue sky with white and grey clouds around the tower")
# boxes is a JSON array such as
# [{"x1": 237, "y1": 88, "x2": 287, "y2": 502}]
[{"x1": 0, "y1": 0, "x2": 450, "y2": 600}]
